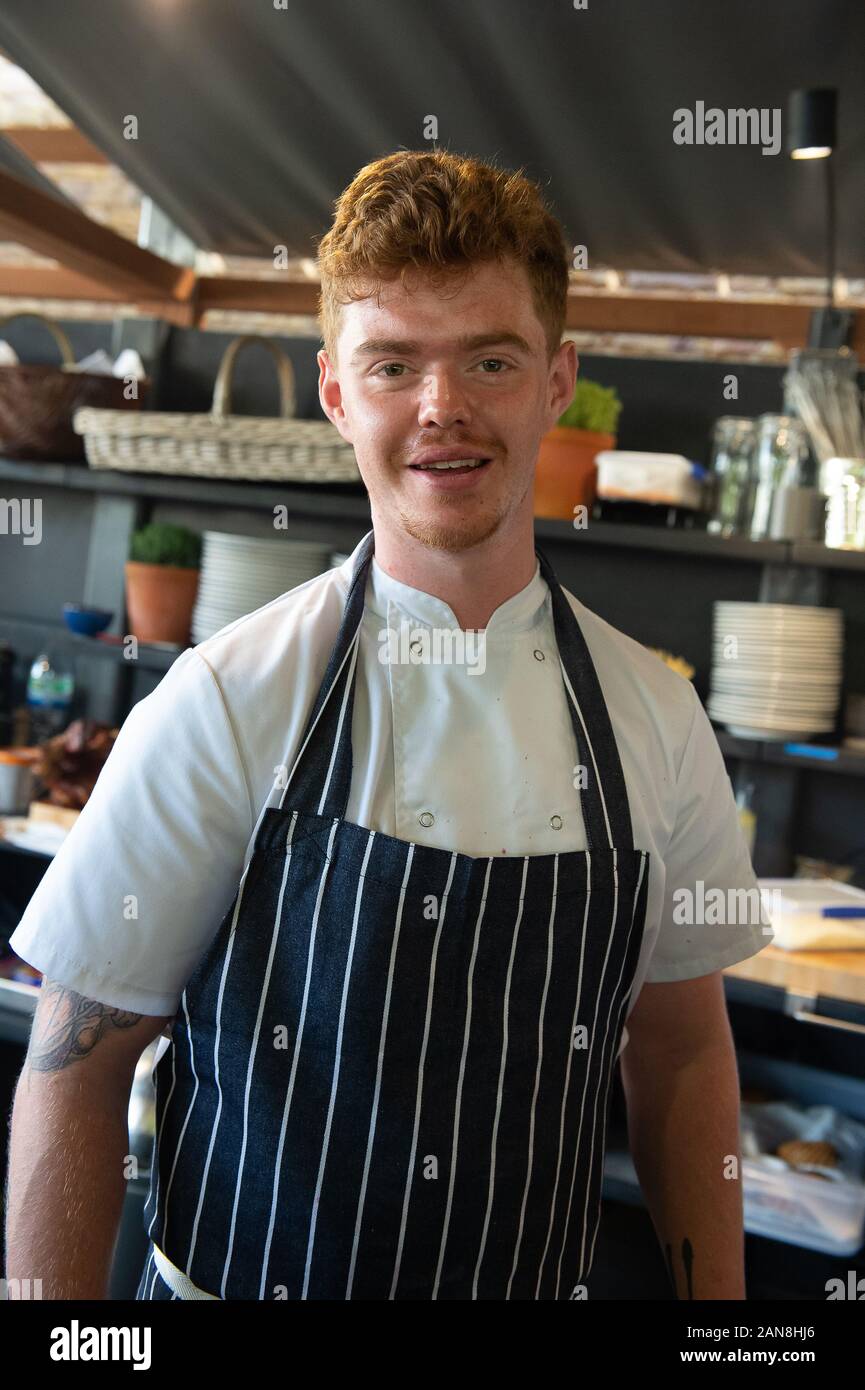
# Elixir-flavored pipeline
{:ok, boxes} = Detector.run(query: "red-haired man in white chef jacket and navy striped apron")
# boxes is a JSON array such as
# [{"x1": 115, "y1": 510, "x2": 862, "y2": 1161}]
[{"x1": 8, "y1": 152, "x2": 770, "y2": 1300}]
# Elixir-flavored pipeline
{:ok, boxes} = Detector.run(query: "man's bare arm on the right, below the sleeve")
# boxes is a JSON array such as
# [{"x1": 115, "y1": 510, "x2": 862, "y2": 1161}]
[{"x1": 622, "y1": 970, "x2": 745, "y2": 1300}]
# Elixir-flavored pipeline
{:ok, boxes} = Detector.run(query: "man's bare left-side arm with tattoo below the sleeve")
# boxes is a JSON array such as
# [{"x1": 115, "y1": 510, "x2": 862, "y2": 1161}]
[{"x1": 6, "y1": 980, "x2": 170, "y2": 1298}]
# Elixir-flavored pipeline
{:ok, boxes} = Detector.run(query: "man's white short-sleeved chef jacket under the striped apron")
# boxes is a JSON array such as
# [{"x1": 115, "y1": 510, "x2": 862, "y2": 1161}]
[{"x1": 11, "y1": 528, "x2": 772, "y2": 1051}]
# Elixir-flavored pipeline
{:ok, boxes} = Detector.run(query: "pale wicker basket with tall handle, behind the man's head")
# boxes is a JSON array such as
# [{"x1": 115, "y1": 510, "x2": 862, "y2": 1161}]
[{"x1": 75, "y1": 335, "x2": 362, "y2": 482}]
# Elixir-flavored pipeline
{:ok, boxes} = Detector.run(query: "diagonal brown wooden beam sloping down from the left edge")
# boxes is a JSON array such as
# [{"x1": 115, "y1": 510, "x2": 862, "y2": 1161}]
[{"x1": 0, "y1": 170, "x2": 195, "y2": 302}]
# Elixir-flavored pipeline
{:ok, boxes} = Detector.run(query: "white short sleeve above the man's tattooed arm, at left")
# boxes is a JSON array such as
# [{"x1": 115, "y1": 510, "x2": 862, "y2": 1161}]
[{"x1": 10, "y1": 648, "x2": 254, "y2": 1016}]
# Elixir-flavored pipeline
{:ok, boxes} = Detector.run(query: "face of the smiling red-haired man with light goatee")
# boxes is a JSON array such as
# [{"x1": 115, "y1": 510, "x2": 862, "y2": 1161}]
[{"x1": 318, "y1": 260, "x2": 577, "y2": 550}]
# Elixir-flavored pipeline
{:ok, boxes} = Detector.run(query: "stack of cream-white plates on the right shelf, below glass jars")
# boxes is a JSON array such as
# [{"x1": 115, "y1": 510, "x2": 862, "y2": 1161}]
[{"x1": 708, "y1": 602, "x2": 844, "y2": 739}]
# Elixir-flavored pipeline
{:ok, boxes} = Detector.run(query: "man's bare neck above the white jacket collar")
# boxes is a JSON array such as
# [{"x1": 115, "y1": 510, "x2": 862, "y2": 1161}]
[{"x1": 375, "y1": 518, "x2": 537, "y2": 631}]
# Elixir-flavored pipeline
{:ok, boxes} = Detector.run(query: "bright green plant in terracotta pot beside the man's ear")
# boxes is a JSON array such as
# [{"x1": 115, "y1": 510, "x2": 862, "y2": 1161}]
[{"x1": 534, "y1": 377, "x2": 622, "y2": 520}]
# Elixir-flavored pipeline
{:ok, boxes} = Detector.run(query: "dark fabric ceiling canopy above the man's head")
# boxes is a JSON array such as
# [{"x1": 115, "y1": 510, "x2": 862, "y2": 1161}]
[{"x1": 0, "y1": 0, "x2": 865, "y2": 277}]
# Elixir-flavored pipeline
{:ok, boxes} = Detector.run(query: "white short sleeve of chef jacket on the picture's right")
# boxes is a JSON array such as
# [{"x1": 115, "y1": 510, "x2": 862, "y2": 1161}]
[{"x1": 645, "y1": 687, "x2": 773, "y2": 983}]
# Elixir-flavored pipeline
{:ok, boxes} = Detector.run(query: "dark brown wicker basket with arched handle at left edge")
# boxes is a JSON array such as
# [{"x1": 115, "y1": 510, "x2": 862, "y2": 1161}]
[{"x1": 0, "y1": 313, "x2": 147, "y2": 463}]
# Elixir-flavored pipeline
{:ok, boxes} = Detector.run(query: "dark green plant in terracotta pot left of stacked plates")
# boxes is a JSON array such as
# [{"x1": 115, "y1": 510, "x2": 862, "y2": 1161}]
[{"x1": 125, "y1": 521, "x2": 202, "y2": 646}]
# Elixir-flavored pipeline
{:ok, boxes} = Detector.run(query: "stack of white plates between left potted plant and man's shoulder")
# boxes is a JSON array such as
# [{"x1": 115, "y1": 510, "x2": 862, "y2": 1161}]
[{"x1": 192, "y1": 531, "x2": 331, "y2": 642}]
